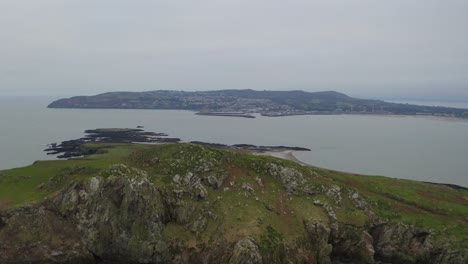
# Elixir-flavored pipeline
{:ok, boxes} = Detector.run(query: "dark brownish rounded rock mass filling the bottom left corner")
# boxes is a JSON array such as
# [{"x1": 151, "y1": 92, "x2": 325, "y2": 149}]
[{"x1": 0, "y1": 205, "x2": 94, "y2": 264}]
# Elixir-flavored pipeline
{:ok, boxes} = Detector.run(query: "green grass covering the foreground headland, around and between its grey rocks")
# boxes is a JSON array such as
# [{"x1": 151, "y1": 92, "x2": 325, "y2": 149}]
[{"x1": 0, "y1": 144, "x2": 468, "y2": 249}]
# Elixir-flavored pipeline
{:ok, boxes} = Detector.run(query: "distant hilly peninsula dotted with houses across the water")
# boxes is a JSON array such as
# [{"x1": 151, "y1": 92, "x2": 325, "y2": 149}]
[{"x1": 48, "y1": 89, "x2": 468, "y2": 118}]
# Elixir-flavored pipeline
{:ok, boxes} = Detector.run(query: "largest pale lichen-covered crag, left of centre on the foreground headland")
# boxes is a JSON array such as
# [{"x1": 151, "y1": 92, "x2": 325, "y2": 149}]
[{"x1": 50, "y1": 165, "x2": 168, "y2": 262}]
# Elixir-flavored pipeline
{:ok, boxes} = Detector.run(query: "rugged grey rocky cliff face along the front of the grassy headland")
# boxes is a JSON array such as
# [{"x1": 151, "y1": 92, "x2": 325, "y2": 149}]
[{"x1": 0, "y1": 154, "x2": 468, "y2": 263}]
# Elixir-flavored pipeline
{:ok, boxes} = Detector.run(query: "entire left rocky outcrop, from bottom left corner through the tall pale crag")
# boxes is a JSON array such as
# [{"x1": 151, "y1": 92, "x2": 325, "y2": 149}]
[{"x1": 0, "y1": 165, "x2": 201, "y2": 263}]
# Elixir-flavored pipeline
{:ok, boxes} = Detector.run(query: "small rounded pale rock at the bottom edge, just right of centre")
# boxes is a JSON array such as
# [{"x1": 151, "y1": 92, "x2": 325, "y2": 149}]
[{"x1": 229, "y1": 238, "x2": 263, "y2": 264}]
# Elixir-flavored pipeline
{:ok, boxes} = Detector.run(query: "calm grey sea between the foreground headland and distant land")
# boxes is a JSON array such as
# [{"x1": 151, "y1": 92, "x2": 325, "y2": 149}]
[{"x1": 0, "y1": 97, "x2": 468, "y2": 187}]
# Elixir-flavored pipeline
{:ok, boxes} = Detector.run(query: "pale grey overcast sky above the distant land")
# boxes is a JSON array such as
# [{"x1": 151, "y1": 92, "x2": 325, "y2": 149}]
[{"x1": 0, "y1": 0, "x2": 468, "y2": 100}]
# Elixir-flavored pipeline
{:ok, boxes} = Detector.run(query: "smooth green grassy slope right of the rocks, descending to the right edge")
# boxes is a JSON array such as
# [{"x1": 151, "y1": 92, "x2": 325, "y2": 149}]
[{"x1": 317, "y1": 169, "x2": 468, "y2": 245}]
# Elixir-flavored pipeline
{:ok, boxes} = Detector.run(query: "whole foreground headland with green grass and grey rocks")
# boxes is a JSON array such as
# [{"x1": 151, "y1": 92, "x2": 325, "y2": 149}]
[{"x1": 0, "y1": 142, "x2": 468, "y2": 263}]
